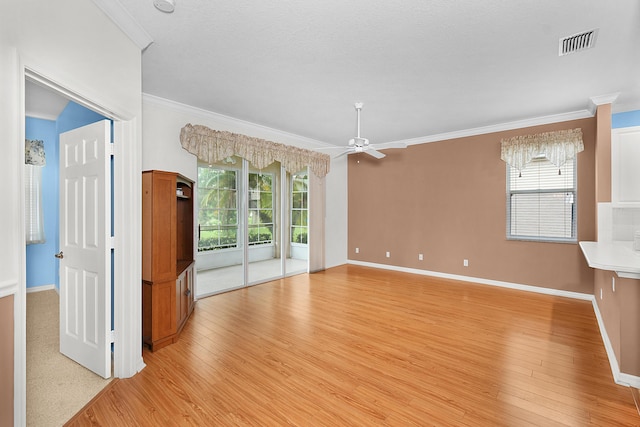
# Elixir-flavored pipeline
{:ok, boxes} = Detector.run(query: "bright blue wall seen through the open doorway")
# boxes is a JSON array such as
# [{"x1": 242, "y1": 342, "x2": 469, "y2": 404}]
[{"x1": 25, "y1": 102, "x2": 105, "y2": 289}]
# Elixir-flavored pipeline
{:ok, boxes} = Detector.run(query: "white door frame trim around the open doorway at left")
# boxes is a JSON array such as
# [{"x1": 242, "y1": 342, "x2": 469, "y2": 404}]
[{"x1": 14, "y1": 65, "x2": 145, "y2": 421}]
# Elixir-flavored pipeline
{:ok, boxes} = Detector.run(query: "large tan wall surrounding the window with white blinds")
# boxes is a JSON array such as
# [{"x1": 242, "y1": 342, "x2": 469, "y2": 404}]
[{"x1": 350, "y1": 118, "x2": 596, "y2": 294}]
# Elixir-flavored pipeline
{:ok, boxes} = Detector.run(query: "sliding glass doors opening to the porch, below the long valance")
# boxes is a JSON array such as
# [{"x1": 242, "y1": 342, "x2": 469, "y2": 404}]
[{"x1": 196, "y1": 157, "x2": 309, "y2": 297}]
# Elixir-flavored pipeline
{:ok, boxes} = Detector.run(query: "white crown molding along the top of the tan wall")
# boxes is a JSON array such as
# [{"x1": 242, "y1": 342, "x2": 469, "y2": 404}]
[{"x1": 380, "y1": 110, "x2": 593, "y2": 145}]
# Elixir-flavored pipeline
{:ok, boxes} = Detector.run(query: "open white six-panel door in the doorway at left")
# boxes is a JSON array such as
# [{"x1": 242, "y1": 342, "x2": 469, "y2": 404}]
[{"x1": 58, "y1": 120, "x2": 111, "y2": 378}]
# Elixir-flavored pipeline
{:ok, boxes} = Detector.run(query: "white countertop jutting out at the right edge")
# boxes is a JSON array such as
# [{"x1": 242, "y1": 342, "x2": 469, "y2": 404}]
[{"x1": 580, "y1": 241, "x2": 640, "y2": 279}]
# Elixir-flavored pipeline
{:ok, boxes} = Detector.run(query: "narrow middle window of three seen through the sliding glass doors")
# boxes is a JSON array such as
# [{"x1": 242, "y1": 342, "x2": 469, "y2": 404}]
[{"x1": 249, "y1": 173, "x2": 273, "y2": 245}]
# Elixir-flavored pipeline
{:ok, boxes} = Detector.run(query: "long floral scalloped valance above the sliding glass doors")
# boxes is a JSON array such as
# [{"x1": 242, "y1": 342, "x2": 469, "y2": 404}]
[{"x1": 180, "y1": 123, "x2": 330, "y2": 178}]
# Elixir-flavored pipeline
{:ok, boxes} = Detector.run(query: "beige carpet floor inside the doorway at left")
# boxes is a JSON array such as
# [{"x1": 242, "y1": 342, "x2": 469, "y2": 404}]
[{"x1": 27, "y1": 290, "x2": 111, "y2": 427}]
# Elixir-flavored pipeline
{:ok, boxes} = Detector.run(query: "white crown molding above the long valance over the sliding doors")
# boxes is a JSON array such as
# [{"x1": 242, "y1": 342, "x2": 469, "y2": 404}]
[{"x1": 142, "y1": 93, "x2": 336, "y2": 148}]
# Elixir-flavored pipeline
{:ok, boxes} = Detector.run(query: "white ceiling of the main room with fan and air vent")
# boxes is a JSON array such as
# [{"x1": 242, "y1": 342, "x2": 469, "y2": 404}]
[{"x1": 31, "y1": 0, "x2": 640, "y2": 145}]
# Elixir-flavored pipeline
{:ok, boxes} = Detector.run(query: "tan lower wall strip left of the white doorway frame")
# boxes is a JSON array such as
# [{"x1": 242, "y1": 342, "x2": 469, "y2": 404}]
[{"x1": 0, "y1": 295, "x2": 14, "y2": 426}]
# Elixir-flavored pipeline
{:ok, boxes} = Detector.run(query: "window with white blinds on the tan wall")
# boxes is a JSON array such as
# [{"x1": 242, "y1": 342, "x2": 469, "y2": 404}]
[{"x1": 507, "y1": 156, "x2": 577, "y2": 242}]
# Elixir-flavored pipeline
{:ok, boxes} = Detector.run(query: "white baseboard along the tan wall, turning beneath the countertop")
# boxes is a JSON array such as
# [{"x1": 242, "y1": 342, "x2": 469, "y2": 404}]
[{"x1": 347, "y1": 260, "x2": 640, "y2": 388}]
